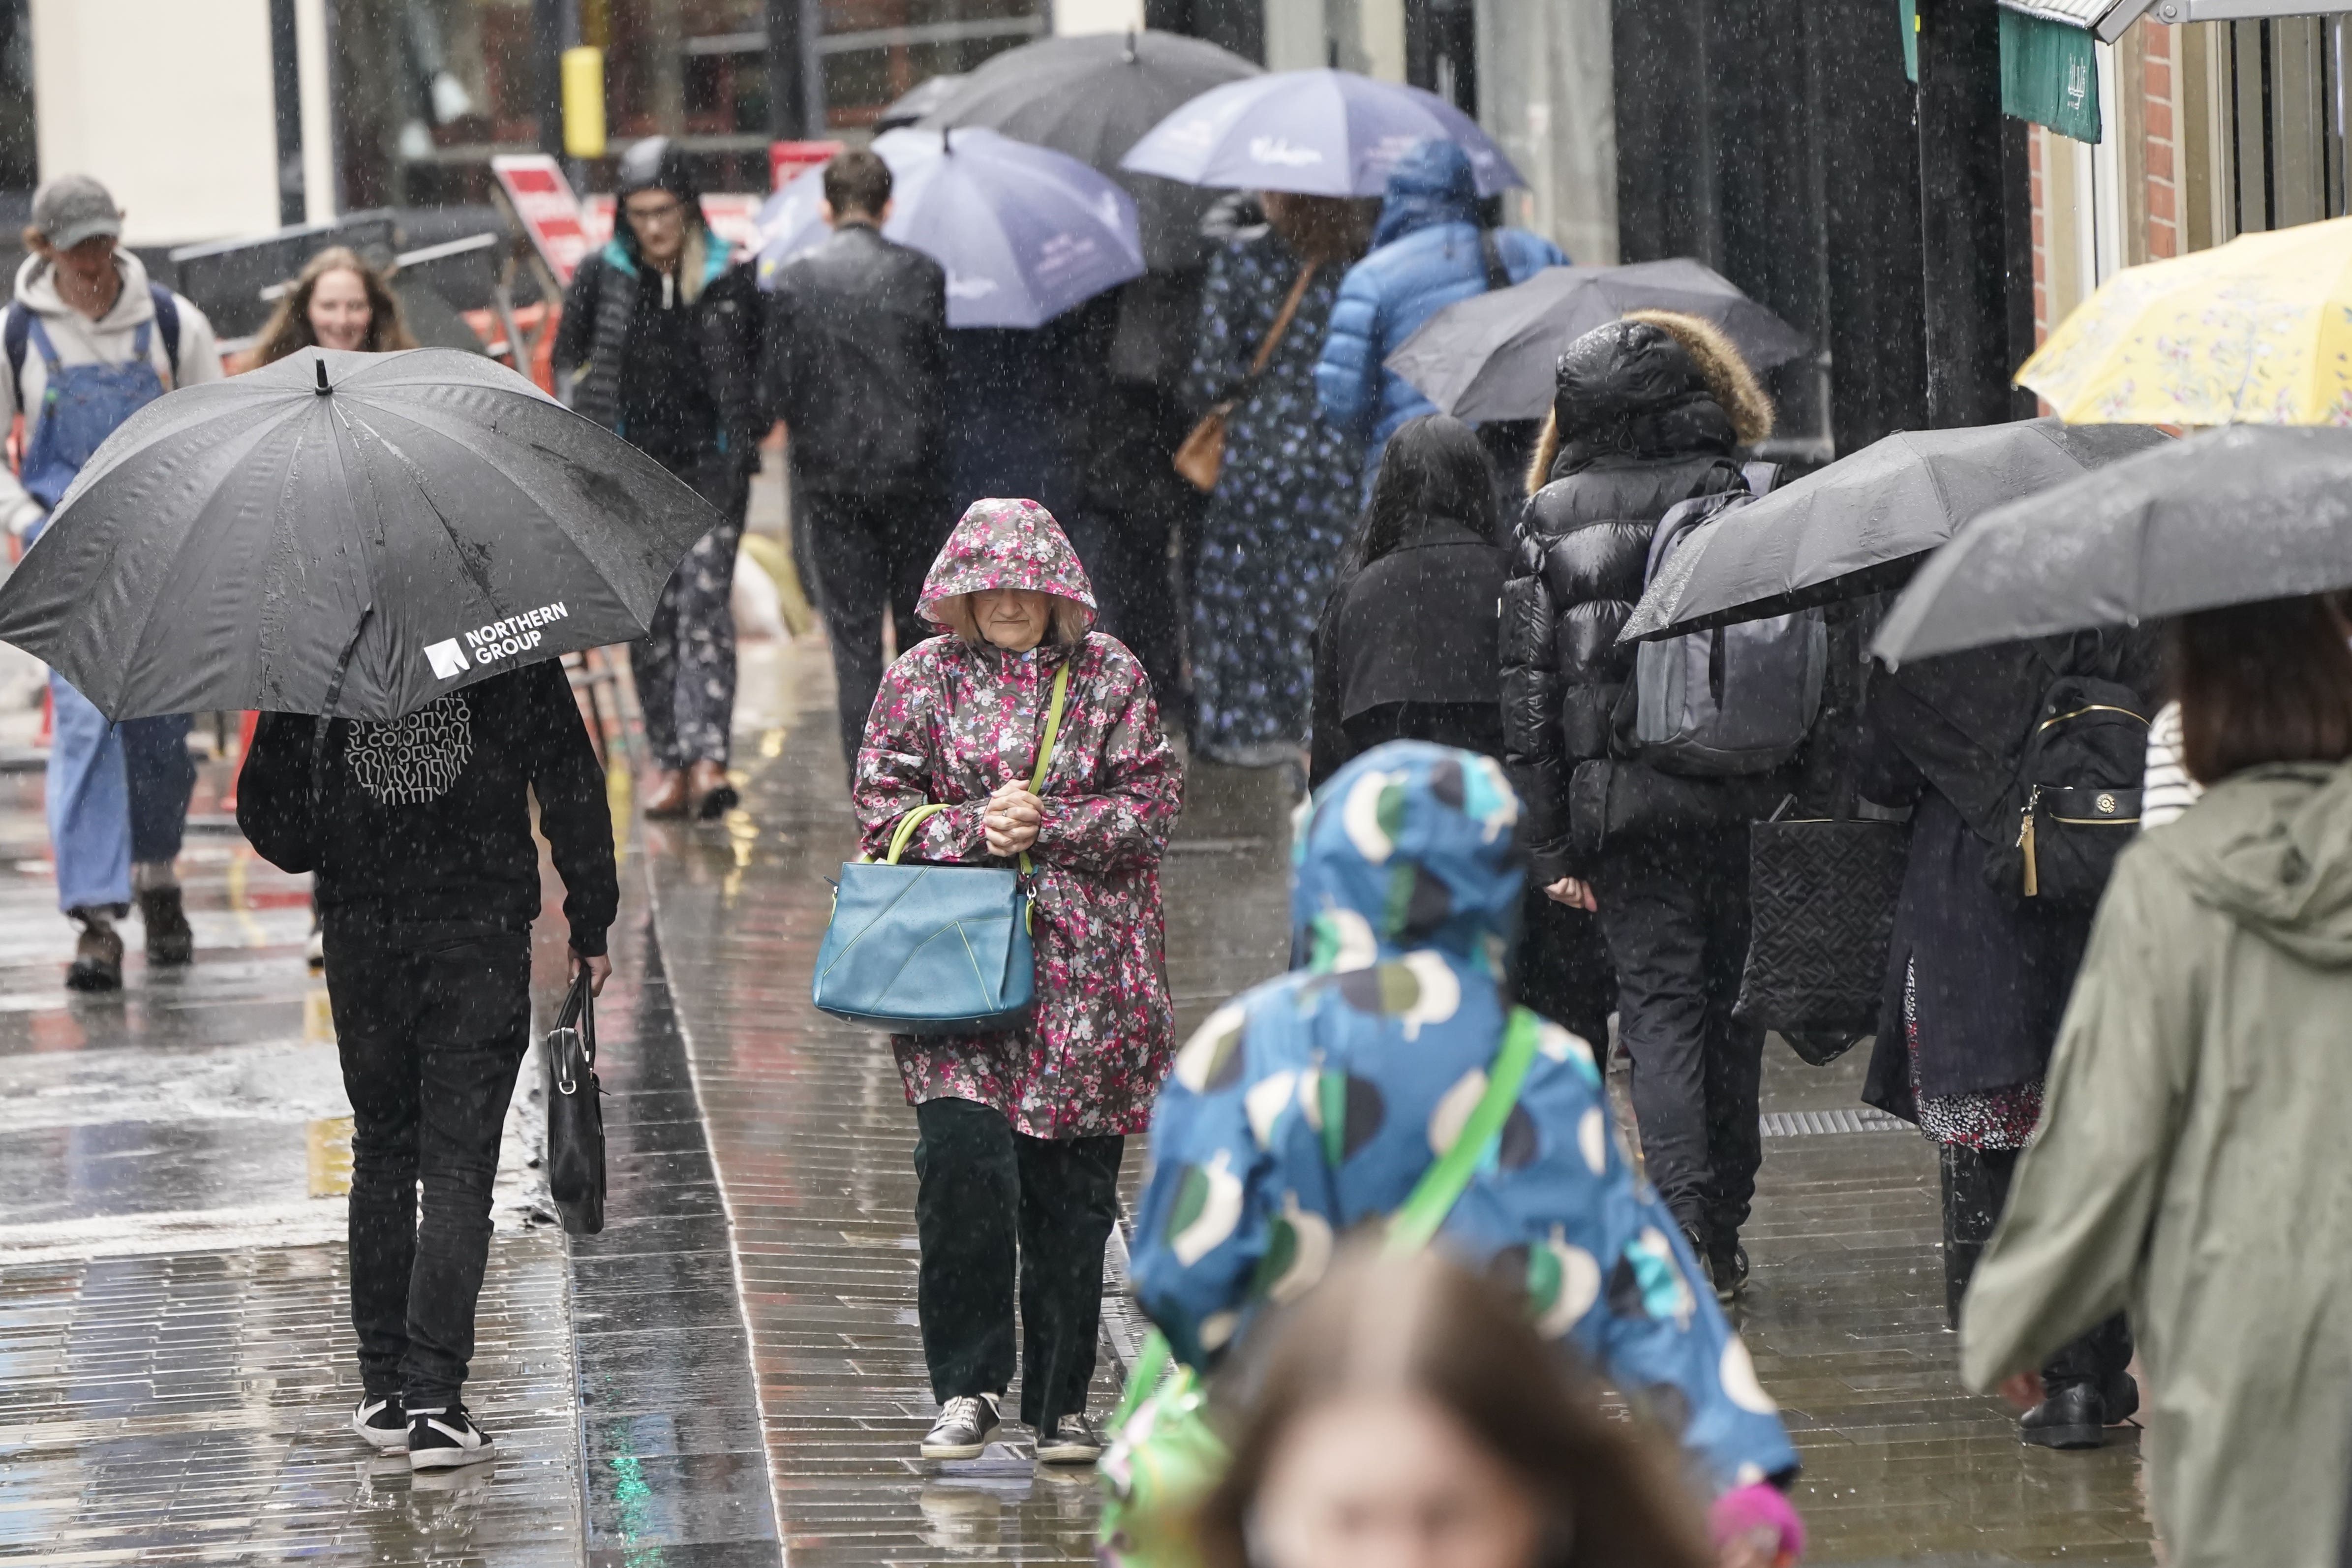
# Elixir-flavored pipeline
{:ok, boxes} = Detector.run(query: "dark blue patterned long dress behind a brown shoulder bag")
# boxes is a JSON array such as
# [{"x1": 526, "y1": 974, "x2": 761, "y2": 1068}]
[{"x1": 1192, "y1": 230, "x2": 1362, "y2": 767}]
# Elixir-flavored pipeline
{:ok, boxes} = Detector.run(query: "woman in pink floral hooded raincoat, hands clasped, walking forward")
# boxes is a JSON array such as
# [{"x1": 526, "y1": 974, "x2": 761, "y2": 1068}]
[{"x1": 854, "y1": 501, "x2": 1183, "y2": 1465}]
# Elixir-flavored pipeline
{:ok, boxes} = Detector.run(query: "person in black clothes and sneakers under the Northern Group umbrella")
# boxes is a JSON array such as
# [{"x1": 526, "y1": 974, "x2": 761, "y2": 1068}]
[{"x1": 238, "y1": 661, "x2": 621, "y2": 1469}]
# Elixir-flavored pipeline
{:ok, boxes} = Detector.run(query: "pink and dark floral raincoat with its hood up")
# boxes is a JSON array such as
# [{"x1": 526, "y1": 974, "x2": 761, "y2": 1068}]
[{"x1": 852, "y1": 501, "x2": 1183, "y2": 1138}]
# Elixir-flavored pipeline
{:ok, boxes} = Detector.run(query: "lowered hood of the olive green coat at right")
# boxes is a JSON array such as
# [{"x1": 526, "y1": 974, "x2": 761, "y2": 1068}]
[{"x1": 2147, "y1": 762, "x2": 2352, "y2": 969}]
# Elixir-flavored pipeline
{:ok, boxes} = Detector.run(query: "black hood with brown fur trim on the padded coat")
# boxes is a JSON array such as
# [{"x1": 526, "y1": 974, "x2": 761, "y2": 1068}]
[{"x1": 1527, "y1": 310, "x2": 1773, "y2": 496}]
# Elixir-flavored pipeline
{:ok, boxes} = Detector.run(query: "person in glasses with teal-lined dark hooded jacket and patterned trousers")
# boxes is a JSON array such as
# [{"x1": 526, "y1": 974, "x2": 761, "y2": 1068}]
[{"x1": 555, "y1": 136, "x2": 771, "y2": 818}]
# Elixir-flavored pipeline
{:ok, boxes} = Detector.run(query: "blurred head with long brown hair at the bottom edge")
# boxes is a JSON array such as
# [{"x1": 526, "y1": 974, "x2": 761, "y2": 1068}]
[{"x1": 1197, "y1": 1251, "x2": 1721, "y2": 1568}]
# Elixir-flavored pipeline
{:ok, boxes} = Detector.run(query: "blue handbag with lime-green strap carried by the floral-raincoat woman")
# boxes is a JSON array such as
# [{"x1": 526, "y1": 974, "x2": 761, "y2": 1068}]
[{"x1": 809, "y1": 663, "x2": 1070, "y2": 1034}]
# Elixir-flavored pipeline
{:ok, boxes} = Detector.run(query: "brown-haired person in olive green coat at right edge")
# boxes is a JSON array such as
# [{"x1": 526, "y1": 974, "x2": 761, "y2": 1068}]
[{"x1": 1961, "y1": 597, "x2": 2352, "y2": 1568}]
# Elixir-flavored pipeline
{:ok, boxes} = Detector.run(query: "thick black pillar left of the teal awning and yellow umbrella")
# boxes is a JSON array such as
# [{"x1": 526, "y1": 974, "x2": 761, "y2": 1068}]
[{"x1": 1919, "y1": 0, "x2": 2014, "y2": 428}]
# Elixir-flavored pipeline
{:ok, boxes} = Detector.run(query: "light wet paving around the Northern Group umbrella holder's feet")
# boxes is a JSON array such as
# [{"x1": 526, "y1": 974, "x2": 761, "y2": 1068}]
[{"x1": 0, "y1": 767, "x2": 581, "y2": 1568}]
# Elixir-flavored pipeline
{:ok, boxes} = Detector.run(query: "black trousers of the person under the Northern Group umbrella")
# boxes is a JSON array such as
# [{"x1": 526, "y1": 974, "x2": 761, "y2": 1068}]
[{"x1": 325, "y1": 912, "x2": 532, "y2": 1408}]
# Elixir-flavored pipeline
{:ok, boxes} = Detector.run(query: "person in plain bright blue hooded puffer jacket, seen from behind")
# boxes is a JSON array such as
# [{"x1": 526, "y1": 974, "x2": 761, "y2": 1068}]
[{"x1": 1315, "y1": 139, "x2": 1569, "y2": 493}]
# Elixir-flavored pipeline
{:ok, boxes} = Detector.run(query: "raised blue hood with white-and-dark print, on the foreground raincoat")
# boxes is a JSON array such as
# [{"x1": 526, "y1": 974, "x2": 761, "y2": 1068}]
[{"x1": 1291, "y1": 740, "x2": 1527, "y2": 976}]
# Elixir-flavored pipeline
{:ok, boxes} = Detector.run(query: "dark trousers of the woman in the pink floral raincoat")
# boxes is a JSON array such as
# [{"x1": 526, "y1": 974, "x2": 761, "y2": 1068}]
[{"x1": 915, "y1": 1100, "x2": 1127, "y2": 1432}]
